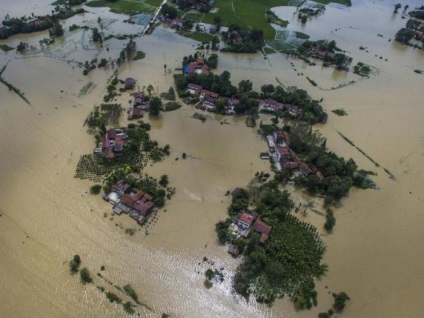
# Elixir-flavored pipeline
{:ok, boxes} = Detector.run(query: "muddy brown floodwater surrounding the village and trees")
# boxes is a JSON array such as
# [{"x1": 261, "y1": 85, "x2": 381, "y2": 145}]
[{"x1": 0, "y1": 0, "x2": 424, "y2": 317}]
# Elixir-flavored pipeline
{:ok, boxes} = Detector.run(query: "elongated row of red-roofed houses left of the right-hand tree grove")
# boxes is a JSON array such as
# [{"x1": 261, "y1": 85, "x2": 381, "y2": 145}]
[{"x1": 262, "y1": 130, "x2": 324, "y2": 180}]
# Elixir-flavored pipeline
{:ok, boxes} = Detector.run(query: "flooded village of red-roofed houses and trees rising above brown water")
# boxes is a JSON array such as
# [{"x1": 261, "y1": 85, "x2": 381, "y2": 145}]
[{"x1": 0, "y1": 0, "x2": 424, "y2": 318}]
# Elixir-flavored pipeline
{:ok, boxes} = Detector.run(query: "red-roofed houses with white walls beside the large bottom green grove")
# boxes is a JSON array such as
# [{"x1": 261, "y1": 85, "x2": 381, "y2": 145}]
[{"x1": 228, "y1": 211, "x2": 272, "y2": 256}]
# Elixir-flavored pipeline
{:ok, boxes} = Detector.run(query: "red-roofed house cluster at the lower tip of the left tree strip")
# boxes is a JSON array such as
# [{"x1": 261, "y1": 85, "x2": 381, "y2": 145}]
[{"x1": 103, "y1": 180, "x2": 154, "y2": 224}]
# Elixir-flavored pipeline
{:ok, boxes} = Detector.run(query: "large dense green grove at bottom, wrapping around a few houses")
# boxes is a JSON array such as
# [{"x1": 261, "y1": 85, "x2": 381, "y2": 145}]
[{"x1": 216, "y1": 176, "x2": 326, "y2": 309}]
